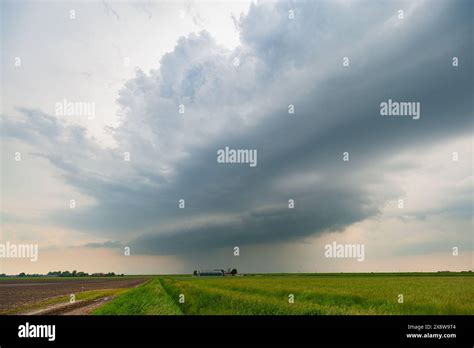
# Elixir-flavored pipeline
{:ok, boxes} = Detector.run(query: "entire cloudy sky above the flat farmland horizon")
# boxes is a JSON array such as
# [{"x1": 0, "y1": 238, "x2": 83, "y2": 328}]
[{"x1": 0, "y1": 0, "x2": 474, "y2": 274}]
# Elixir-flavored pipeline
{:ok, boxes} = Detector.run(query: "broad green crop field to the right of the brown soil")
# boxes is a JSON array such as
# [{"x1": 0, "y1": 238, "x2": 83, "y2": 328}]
[{"x1": 94, "y1": 273, "x2": 474, "y2": 315}]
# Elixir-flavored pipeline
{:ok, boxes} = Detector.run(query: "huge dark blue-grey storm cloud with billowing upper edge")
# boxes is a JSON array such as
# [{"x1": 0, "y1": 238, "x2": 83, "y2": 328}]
[{"x1": 2, "y1": 1, "x2": 473, "y2": 255}]
